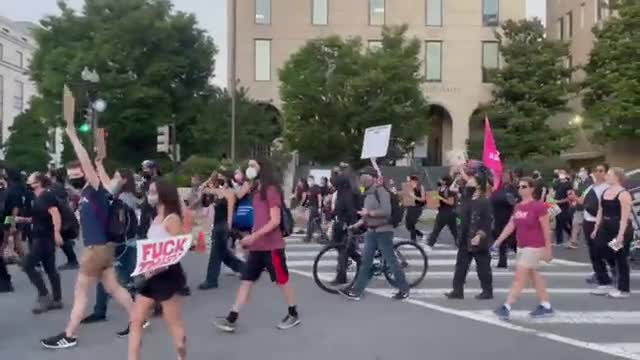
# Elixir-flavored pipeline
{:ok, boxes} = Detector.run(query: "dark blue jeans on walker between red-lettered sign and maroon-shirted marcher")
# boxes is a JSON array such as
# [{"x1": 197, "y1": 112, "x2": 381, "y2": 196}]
[{"x1": 205, "y1": 224, "x2": 244, "y2": 286}]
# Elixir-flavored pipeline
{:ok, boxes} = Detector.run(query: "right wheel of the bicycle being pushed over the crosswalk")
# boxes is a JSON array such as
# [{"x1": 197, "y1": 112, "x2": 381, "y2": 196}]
[{"x1": 384, "y1": 241, "x2": 429, "y2": 288}]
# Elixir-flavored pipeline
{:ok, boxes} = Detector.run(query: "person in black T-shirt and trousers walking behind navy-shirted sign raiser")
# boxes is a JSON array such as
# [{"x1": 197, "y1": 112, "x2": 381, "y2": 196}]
[{"x1": 23, "y1": 172, "x2": 63, "y2": 314}]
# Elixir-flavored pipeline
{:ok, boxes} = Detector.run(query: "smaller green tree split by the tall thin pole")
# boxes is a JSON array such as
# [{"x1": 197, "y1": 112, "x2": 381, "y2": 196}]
[{"x1": 190, "y1": 87, "x2": 281, "y2": 159}]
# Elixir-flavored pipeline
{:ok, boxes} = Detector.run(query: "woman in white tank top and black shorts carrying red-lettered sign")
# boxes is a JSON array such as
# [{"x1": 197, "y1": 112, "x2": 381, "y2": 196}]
[{"x1": 129, "y1": 179, "x2": 187, "y2": 360}]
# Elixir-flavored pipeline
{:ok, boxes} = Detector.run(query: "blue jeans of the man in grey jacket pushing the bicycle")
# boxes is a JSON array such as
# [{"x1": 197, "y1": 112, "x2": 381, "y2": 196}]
[{"x1": 353, "y1": 231, "x2": 409, "y2": 295}]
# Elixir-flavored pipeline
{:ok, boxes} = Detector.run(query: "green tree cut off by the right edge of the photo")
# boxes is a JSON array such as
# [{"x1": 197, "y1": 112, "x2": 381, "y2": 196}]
[{"x1": 583, "y1": 0, "x2": 640, "y2": 143}]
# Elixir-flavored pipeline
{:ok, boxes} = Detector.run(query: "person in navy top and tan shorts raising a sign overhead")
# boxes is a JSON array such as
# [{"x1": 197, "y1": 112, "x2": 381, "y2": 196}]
[{"x1": 41, "y1": 86, "x2": 133, "y2": 349}]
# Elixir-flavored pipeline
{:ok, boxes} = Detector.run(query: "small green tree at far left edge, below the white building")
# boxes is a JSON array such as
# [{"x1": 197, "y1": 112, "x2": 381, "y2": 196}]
[{"x1": 3, "y1": 98, "x2": 51, "y2": 172}]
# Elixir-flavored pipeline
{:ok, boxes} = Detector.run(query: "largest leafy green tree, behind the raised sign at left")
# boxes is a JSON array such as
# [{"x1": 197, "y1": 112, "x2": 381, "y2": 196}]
[{"x1": 31, "y1": 0, "x2": 217, "y2": 165}]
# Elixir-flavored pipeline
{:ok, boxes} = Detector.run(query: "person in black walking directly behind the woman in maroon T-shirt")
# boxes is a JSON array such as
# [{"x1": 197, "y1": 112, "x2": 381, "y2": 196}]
[{"x1": 491, "y1": 171, "x2": 519, "y2": 269}]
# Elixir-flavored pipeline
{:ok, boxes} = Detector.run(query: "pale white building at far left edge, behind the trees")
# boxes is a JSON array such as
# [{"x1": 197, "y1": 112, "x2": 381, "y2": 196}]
[{"x1": 0, "y1": 16, "x2": 62, "y2": 163}]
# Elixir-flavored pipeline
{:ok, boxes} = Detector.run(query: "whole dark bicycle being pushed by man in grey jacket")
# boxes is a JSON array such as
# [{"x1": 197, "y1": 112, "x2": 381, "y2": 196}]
[{"x1": 313, "y1": 229, "x2": 429, "y2": 294}]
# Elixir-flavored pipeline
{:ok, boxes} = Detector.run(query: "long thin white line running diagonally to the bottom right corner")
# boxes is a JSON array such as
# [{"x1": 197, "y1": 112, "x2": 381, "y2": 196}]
[{"x1": 289, "y1": 269, "x2": 640, "y2": 360}]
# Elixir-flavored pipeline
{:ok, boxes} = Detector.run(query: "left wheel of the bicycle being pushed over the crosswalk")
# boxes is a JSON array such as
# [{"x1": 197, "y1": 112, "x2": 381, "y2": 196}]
[{"x1": 313, "y1": 244, "x2": 360, "y2": 294}]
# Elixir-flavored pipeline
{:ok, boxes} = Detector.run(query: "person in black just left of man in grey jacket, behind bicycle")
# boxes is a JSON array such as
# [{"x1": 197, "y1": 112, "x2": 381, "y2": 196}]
[{"x1": 331, "y1": 174, "x2": 360, "y2": 285}]
